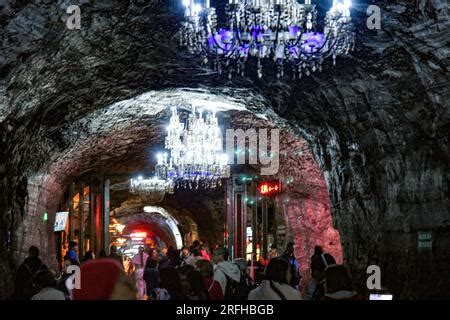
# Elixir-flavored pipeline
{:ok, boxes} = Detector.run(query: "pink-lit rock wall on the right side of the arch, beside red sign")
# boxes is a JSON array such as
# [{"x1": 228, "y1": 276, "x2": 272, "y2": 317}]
[{"x1": 276, "y1": 133, "x2": 343, "y2": 287}]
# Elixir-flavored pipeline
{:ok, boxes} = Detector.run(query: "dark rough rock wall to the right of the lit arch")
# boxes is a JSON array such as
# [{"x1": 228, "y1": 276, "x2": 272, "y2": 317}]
[{"x1": 266, "y1": 1, "x2": 450, "y2": 298}]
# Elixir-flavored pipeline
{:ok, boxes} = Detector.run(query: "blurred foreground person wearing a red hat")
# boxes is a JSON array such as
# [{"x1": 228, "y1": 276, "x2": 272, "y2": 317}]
[{"x1": 73, "y1": 258, "x2": 136, "y2": 300}]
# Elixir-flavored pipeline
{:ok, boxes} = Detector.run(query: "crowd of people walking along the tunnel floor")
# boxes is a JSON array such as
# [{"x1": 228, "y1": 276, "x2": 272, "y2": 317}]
[{"x1": 15, "y1": 241, "x2": 360, "y2": 300}]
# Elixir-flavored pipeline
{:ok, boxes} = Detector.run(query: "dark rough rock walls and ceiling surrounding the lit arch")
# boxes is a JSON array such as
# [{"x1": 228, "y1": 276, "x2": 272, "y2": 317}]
[{"x1": 0, "y1": 0, "x2": 450, "y2": 298}]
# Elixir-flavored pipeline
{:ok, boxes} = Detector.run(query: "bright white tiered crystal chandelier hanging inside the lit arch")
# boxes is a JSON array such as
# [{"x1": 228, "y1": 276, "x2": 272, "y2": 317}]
[{"x1": 155, "y1": 107, "x2": 230, "y2": 189}]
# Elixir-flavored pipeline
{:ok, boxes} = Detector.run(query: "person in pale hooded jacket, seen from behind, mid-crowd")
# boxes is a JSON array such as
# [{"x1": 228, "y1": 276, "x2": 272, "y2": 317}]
[{"x1": 213, "y1": 247, "x2": 241, "y2": 299}]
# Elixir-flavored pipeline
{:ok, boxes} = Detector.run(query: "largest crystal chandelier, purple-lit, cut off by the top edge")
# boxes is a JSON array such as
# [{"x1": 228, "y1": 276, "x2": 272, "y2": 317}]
[{"x1": 180, "y1": 0, "x2": 354, "y2": 79}]
